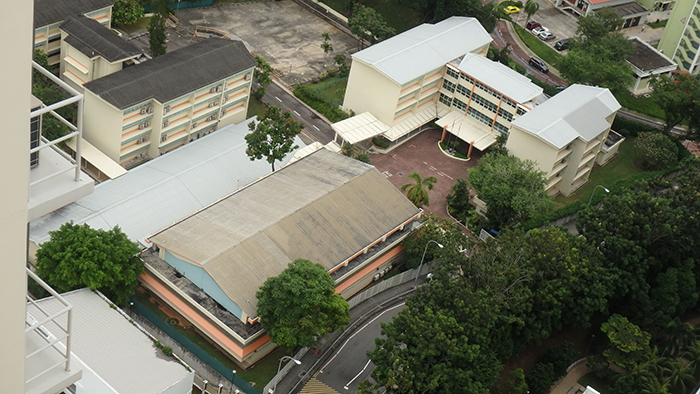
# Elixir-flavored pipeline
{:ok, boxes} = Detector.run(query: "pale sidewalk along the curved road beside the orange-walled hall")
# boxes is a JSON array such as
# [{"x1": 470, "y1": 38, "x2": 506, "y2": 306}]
[{"x1": 274, "y1": 281, "x2": 422, "y2": 394}]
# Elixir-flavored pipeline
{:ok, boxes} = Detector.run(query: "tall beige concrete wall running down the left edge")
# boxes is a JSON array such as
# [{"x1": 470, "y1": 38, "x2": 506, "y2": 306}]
[{"x1": 0, "y1": 1, "x2": 34, "y2": 393}]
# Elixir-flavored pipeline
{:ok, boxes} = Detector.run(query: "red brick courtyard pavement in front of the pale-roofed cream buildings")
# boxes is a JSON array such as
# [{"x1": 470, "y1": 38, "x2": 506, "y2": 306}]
[{"x1": 370, "y1": 130, "x2": 482, "y2": 217}]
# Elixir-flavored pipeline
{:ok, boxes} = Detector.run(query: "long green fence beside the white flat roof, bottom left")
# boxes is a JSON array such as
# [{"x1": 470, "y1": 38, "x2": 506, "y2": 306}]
[{"x1": 131, "y1": 299, "x2": 262, "y2": 394}]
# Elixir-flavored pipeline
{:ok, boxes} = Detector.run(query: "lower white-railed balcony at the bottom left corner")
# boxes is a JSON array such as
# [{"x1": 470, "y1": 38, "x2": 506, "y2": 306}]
[{"x1": 24, "y1": 269, "x2": 82, "y2": 394}]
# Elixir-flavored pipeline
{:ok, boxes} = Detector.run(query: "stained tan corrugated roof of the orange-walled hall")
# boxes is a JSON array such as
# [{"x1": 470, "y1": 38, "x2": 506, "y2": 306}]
[{"x1": 150, "y1": 149, "x2": 420, "y2": 316}]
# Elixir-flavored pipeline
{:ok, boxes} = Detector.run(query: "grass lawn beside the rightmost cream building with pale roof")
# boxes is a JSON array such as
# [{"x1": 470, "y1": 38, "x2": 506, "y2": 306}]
[{"x1": 554, "y1": 138, "x2": 643, "y2": 207}]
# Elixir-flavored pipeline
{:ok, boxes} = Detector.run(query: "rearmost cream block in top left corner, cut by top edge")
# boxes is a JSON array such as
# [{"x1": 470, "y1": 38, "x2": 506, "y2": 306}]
[{"x1": 34, "y1": 0, "x2": 114, "y2": 66}]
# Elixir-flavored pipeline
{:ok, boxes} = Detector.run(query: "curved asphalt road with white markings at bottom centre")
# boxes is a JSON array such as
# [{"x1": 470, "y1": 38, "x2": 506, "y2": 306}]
[{"x1": 316, "y1": 303, "x2": 404, "y2": 393}]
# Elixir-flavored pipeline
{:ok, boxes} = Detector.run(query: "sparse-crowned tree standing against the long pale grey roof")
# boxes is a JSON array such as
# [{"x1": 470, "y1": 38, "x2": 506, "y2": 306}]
[{"x1": 245, "y1": 106, "x2": 304, "y2": 171}]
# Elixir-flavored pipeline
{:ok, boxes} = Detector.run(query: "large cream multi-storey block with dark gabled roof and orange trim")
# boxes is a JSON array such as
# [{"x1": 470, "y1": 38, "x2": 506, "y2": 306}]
[{"x1": 83, "y1": 38, "x2": 255, "y2": 168}]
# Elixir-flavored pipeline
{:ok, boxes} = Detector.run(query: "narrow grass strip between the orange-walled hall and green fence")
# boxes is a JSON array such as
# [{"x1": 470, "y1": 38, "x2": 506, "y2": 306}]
[{"x1": 134, "y1": 292, "x2": 293, "y2": 390}]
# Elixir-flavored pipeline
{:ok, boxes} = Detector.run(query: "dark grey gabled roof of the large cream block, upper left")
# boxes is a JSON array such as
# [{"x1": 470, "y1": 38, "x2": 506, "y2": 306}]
[{"x1": 83, "y1": 38, "x2": 255, "y2": 109}]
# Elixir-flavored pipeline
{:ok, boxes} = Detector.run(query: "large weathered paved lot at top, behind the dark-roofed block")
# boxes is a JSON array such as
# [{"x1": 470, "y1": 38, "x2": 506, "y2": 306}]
[{"x1": 175, "y1": 0, "x2": 359, "y2": 85}]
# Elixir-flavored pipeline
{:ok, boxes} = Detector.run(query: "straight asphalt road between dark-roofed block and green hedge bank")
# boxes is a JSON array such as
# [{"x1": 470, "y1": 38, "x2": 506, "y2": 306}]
[{"x1": 263, "y1": 82, "x2": 335, "y2": 145}]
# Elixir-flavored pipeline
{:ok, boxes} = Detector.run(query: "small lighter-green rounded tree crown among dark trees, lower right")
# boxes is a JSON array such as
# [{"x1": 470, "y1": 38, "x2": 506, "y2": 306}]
[{"x1": 600, "y1": 313, "x2": 651, "y2": 368}]
